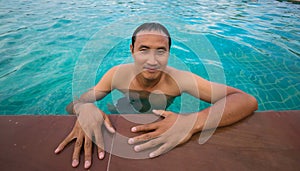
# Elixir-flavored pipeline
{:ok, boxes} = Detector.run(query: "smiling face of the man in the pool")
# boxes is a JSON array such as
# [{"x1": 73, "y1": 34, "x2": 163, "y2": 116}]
[{"x1": 130, "y1": 31, "x2": 169, "y2": 80}]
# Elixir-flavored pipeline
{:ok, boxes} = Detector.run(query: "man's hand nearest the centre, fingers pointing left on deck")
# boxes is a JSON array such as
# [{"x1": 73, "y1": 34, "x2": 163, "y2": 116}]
[{"x1": 128, "y1": 110, "x2": 197, "y2": 158}]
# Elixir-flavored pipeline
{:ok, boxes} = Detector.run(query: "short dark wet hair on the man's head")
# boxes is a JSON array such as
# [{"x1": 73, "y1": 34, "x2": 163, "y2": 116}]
[{"x1": 131, "y1": 23, "x2": 171, "y2": 49}]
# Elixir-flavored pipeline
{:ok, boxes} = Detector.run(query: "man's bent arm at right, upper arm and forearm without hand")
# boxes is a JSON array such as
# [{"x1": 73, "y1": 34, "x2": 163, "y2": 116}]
[{"x1": 186, "y1": 74, "x2": 258, "y2": 132}]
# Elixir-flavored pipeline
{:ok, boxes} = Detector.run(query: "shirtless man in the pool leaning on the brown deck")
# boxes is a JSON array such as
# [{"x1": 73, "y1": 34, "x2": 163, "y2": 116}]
[{"x1": 55, "y1": 23, "x2": 257, "y2": 168}]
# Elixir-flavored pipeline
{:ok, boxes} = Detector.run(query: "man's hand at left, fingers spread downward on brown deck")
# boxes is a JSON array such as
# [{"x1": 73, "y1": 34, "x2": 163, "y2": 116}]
[{"x1": 55, "y1": 103, "x2": 115, "y2": 169}]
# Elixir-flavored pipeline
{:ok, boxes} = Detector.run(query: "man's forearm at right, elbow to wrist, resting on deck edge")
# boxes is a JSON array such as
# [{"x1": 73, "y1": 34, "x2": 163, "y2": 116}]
[{"x1": 193, "y1": 93, "x2": 257, "y2": 132}]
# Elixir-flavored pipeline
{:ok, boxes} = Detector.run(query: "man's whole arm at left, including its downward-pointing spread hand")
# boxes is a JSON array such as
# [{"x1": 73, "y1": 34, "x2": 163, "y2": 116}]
[{"x1": 55, "y1": 68, "x2": 115, "y2": 169}]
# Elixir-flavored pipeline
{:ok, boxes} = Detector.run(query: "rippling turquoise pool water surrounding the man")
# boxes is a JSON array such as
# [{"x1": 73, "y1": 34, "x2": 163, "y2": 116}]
[{"x1": 0, "y1": 0, "x2": 300, "y2": 114}]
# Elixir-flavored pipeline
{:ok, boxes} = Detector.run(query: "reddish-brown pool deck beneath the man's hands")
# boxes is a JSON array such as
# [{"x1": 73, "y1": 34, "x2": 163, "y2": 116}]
[{"x1": 0, "y1": 110, "x2": 300, "y2": 171}]
